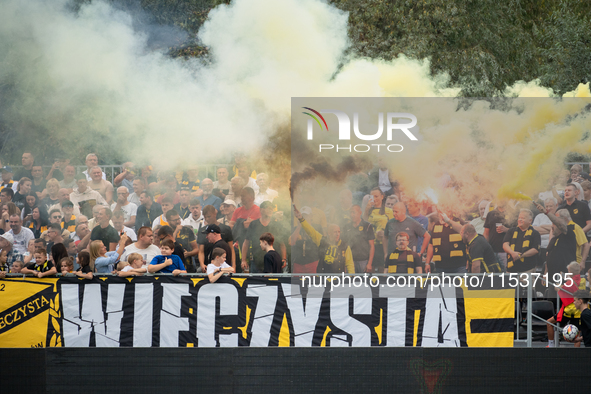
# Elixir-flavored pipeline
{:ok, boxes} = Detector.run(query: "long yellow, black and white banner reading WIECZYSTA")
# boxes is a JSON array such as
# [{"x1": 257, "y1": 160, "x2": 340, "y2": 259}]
[{"x1": 0, "y1": 276, "x2": 515, "y2": 347}]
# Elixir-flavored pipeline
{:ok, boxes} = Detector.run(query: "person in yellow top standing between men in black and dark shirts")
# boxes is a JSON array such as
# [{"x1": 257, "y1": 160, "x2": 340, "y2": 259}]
[{"x1": 363, "y1": 187, "x2": 394, "y2": 272}]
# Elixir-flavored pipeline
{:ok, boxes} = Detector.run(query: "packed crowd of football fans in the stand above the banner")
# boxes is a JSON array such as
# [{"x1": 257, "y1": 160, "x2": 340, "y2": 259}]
[{"x1": 0, "y1": 151, "x2": 591, "y2": 288}]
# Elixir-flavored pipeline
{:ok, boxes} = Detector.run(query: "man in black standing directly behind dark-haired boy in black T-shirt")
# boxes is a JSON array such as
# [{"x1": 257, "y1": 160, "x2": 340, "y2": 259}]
[{"x1": 241, "y1": 201, "x2": 287, "y2": 273}]
